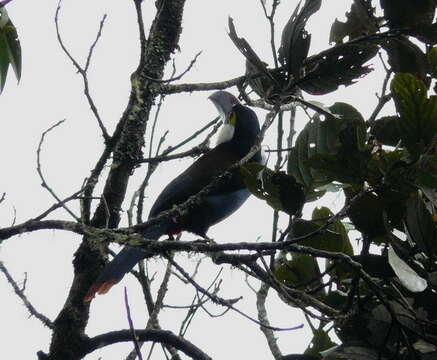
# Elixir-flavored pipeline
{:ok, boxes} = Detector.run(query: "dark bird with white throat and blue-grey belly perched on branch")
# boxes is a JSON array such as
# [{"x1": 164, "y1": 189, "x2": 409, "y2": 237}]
[{"x1": 84, "y1": 90, "x2": 262, "y2": 301}]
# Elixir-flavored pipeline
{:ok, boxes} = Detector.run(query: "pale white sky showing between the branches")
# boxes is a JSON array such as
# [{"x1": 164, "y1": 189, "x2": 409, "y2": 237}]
[{"x1": 0, "y1": 0, "x2": 388, "y2": 359}]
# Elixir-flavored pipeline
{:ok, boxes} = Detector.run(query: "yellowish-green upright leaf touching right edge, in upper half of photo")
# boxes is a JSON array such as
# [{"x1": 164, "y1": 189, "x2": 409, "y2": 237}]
[{"x1": 391, "y1": 73, "x2": 437, "y2": 158}]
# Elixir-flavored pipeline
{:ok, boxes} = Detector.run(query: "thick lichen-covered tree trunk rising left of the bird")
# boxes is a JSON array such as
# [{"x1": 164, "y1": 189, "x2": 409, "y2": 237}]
[{"x1": 44, "y1": 0, "x2": 185, "y2": 360}]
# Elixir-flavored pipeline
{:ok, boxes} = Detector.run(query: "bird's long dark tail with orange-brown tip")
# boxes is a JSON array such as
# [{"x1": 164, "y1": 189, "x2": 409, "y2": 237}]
[{"x1": 84, "y1": 224, "x2": 167, "y2": 301}]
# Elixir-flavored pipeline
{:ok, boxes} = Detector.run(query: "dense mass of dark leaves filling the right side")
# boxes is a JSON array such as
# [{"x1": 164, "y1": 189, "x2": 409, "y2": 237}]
[{"x1": 230, "y1": 0, "x2": 437, "y2": 359}]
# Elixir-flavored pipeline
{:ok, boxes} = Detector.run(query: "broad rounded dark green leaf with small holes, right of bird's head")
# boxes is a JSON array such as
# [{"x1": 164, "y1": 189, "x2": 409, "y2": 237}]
[{"x1": 288, "y1": 103, "x2": 371, "y2": 201}]
